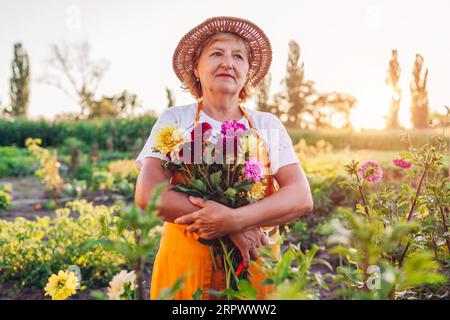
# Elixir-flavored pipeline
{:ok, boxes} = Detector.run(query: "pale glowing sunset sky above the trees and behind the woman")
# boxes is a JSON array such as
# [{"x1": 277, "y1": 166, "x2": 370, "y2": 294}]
[{"x1": 0, "y1": 0, "x2": 450, "y2": 128}]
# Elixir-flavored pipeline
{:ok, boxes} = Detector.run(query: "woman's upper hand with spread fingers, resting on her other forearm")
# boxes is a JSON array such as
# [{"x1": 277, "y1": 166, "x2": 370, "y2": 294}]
[{"x1": 175, "y1": 197, "x2": 240, "y2": 239}]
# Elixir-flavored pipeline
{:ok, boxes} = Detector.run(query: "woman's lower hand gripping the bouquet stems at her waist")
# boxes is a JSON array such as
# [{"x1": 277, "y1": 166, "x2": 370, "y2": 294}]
[{"x1": 229, "y1": 228, "x2": 269, "y2": 269}]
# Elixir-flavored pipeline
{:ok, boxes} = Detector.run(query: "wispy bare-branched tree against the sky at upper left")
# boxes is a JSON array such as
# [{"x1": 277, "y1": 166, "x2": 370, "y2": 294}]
[{"x1": 39, "y1": 42, "x2": 109, "y2": 118}]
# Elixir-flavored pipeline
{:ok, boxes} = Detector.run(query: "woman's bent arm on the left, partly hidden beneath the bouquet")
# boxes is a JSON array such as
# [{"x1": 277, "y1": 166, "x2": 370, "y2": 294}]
[{"x1": 134, "y1": 158, "x2": 199, "y2": 222}]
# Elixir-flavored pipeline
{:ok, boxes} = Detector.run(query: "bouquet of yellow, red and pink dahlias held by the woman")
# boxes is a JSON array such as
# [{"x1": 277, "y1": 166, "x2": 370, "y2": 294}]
[{"x1": 153, "y1": 120, "x2": 268, "y2": 289}]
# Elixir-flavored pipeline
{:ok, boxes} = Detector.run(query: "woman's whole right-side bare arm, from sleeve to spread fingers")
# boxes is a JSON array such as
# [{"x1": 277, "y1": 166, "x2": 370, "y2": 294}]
[{"x1": 175, "y1": 164, "x2": 313, "y2": 239}]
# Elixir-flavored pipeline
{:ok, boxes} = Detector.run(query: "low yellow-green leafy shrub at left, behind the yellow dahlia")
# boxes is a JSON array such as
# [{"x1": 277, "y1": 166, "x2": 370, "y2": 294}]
[{"x1": 0, "y1": 200, "x2": 133, "y2": 287}]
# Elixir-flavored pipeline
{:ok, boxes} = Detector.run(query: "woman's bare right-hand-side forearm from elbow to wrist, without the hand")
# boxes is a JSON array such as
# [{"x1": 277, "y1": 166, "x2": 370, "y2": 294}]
[{"x1": 235, "y1": 185, "x2": 313, "y2": 231}]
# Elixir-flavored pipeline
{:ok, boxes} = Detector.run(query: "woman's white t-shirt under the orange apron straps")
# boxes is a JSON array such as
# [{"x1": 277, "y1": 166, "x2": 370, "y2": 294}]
[{"x1": 136, "y1": 103, "x2": 300, "y2": 174}]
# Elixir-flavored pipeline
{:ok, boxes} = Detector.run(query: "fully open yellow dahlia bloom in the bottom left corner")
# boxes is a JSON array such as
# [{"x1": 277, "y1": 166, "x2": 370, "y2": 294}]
[{"x1": 44, "y1": 270, "x2": 78, "y2": 300}]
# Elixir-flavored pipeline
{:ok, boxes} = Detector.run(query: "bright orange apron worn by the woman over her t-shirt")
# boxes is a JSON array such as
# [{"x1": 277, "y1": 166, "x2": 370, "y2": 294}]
[{"x1": 150, "y1": 101, "x2": 280, "y2": 300}]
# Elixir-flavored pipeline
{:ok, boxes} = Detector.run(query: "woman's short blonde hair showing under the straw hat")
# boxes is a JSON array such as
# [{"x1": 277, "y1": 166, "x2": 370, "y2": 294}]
[{"x1": 181, "y1": 32, "x2": 253, "y2": 102}]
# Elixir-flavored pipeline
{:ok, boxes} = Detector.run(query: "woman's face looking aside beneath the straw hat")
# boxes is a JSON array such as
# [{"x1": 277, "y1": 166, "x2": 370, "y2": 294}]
[{"x1": 194, "y1": 35, "x2": 249, "y2": 99}]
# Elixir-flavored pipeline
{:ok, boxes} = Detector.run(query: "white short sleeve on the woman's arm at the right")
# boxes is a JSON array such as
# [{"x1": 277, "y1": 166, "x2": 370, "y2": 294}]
[{"x1": 268, "y1": 115, "x2": 300, "y2": 174}]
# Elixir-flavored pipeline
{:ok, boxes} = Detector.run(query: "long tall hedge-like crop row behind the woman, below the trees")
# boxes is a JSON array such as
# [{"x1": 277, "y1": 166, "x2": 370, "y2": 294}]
[{"x1": 0, "y1": 116, "x2": 446, "y2": 151}]
